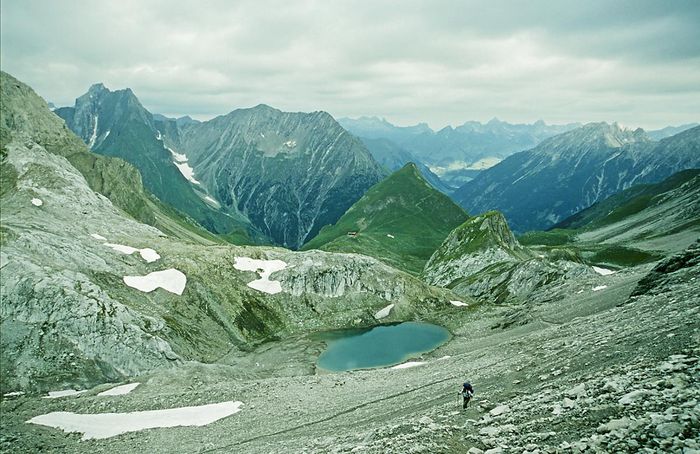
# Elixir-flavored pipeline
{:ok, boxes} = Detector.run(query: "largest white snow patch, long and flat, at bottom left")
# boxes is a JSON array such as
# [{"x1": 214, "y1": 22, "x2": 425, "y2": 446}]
[{"x1": 27, "y1": 401, "x2": 243, "y2": 440}]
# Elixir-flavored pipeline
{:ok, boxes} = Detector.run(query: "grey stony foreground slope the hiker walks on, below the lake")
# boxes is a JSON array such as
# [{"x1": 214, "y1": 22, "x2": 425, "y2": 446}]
[{"x1": 0, "y1": 247, "x2": 700, "y2": 453}]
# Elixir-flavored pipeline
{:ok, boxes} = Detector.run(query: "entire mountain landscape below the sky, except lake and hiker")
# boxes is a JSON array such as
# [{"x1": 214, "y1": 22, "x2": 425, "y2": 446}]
[{"x1": 0, "y1": 72, "x2": 700, "y2": 454}]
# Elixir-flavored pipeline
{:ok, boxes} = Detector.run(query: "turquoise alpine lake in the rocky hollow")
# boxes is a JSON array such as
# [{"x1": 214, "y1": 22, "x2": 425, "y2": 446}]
[{"x1": 315, "y1": 322, "x2": 450, "y2": 372}]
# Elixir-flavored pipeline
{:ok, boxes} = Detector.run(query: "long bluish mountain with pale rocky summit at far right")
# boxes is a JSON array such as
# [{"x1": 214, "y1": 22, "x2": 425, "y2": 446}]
[{"x1": 454, "y1": 123, "x2": 700, "y2": 232}]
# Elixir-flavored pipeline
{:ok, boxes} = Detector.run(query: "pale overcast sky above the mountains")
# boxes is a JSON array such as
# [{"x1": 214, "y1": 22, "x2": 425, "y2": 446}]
[{"x1": 0, "y1": 0, "x2": 700, "y2": 129}]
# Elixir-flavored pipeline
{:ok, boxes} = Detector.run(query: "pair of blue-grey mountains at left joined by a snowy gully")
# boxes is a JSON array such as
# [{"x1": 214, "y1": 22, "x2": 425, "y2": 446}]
[{"x1": 55, "y1": 84, "x2": 386, "y2": 249}]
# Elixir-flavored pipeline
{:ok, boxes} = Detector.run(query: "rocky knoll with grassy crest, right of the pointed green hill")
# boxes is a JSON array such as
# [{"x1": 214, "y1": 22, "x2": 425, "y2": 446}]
[{"x1": 422, "y1": 211, "x2": 592, "y2": 303}]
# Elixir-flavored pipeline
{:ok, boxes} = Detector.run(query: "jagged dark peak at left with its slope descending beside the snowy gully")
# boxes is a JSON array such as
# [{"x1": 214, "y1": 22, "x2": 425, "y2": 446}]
[{"x1": 55, "y1": 84, "x2": 261, "y2": 244}]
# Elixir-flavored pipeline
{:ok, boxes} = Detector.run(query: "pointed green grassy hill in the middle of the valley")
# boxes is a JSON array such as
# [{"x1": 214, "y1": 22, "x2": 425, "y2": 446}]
[{"x1": 302, "y1": 163, "x2": 468, "y2": 274}]
